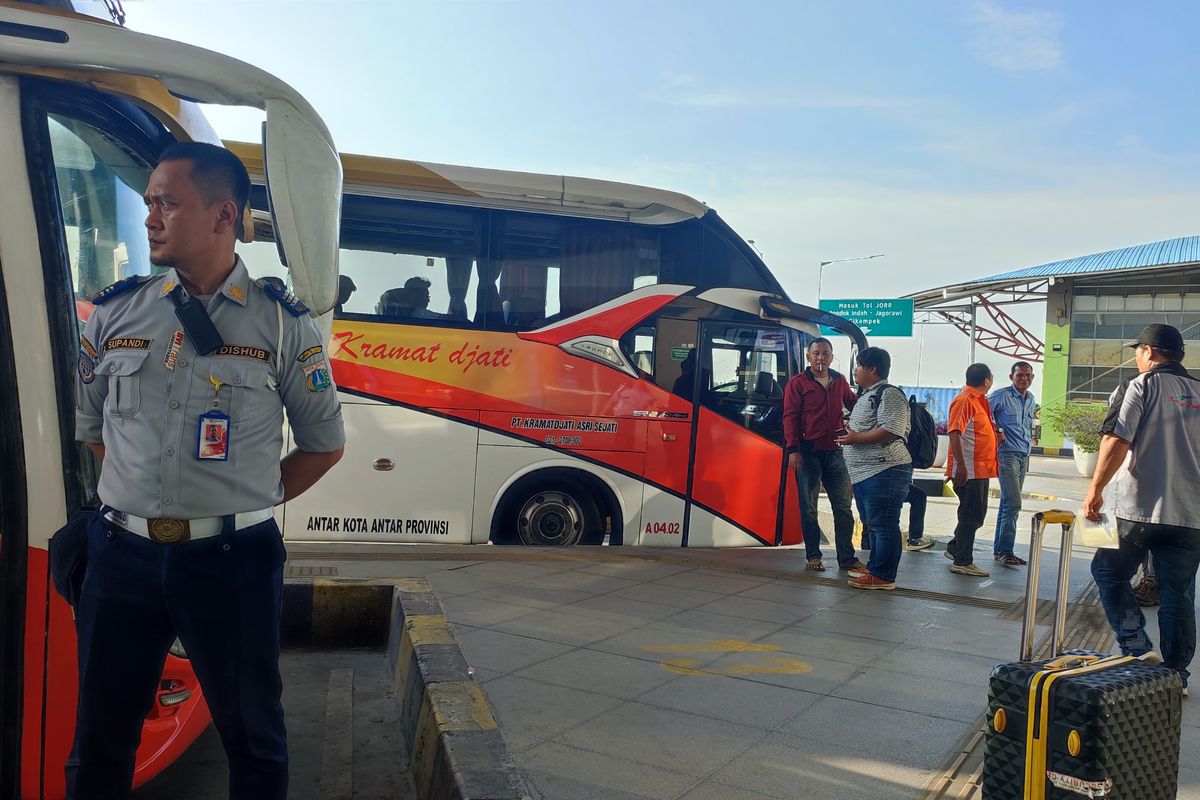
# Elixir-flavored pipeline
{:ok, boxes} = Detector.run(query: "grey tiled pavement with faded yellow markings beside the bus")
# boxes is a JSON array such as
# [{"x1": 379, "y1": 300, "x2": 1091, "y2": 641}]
[{"x1": 288, "y1": 457, "x2": 1200, "y2": 800}]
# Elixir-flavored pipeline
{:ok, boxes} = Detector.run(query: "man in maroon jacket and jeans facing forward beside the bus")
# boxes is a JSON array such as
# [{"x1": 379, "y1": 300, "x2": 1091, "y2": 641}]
[{"x1": 784, "y1": 338, "x2": 865, "y2": 572}]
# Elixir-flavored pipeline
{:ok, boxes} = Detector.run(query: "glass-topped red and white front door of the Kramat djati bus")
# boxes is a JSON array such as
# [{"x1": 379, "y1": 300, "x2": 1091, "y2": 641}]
[{"x1": 684, "y1": 320, "x2": 797, "y2": 547}]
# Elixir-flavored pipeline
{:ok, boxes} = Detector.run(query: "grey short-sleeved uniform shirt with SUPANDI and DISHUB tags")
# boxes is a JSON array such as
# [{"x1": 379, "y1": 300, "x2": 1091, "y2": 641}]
[{"x1": 76, "y1": 258, "x2": 346, "y2": 519}]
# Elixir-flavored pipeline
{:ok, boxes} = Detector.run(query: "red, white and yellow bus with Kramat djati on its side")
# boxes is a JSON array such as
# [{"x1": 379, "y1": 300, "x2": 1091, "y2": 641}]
[{"x1": 232, "y1": 145, "x2": 864, "y2": 547}]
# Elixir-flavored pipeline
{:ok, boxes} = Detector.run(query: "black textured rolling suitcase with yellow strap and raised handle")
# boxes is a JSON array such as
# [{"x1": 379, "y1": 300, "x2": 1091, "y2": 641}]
[{"x1": 983, "y1": 511, "x2": 1183, "y2": 800}]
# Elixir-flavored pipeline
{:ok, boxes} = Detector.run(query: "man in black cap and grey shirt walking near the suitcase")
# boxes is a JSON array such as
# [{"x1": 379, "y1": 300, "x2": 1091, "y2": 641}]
[{"x1": 1084, "y1": 324, "x2": 1200, "y2": 694}]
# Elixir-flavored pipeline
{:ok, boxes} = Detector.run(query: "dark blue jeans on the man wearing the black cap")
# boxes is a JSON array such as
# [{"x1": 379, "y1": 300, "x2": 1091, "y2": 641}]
[{"x1": 1092, "y1": 518, "x2": 1200, "y2": 686}]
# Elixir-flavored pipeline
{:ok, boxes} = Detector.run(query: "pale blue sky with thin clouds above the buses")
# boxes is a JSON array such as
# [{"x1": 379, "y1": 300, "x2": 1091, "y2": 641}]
[{"x1": 79, "y1": 0, "x2": 1200, "y2": 387}]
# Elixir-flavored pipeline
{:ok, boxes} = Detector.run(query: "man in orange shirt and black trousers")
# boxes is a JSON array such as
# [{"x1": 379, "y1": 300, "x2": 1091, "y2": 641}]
[{"x1": 946, "y1": 363, "x2": 1000, "y2": 578}]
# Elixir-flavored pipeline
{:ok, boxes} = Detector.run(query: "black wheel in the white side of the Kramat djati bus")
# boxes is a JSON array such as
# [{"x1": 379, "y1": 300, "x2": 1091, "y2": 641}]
[{"x1": 492, "y1": 470, "x2": 610, "y2": 547}]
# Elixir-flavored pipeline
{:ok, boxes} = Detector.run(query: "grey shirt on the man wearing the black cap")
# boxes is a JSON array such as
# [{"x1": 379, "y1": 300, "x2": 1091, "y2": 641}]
[{"x1": 1100, "y1": 362, "x2": 1200, "y2": 529}]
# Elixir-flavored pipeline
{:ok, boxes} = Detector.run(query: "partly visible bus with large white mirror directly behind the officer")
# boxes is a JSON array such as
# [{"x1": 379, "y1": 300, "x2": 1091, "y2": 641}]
[{"x1": 0, "y1": 1, "x2": 341, "y2": 800}]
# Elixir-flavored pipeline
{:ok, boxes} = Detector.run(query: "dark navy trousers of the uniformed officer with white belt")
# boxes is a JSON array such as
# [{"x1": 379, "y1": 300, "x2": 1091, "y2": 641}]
[{"x1": 66, "y1": 516, "x2": 288, "y2": 800}]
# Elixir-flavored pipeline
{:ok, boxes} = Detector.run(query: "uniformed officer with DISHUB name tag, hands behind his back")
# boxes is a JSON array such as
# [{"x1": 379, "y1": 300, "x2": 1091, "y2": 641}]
[{"x1": 67, "y1": 143, "x2": 346, "y2": 800}]
